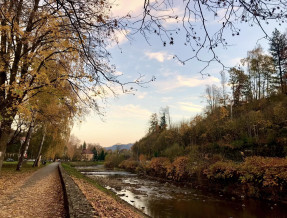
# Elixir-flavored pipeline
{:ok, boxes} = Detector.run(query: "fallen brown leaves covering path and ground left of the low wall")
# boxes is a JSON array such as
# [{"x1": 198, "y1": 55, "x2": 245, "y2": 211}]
[{"x1": 0, "y1": 164, "x2": 65, "y2": 218}]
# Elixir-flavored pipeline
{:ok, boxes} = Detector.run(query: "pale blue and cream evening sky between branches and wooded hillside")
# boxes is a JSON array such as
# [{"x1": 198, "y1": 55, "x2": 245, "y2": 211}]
[{"x1": 72, "y1": 0, "x2": 285, "y2": 147}]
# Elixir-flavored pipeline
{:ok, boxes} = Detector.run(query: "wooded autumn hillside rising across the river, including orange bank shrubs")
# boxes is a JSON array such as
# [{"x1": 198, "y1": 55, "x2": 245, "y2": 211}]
[{"x1": 106, "y1": 30, "x2": 287, "y2": 198}]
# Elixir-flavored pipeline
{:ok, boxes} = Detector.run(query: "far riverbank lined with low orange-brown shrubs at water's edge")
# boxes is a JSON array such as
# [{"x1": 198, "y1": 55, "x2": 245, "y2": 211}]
[{"x1": 120, "y1": 156, "x2": 287, "y2": 202}]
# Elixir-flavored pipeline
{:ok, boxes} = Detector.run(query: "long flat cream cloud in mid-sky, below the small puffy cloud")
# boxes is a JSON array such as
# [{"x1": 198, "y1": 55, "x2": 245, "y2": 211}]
[{"x1": 158, "y1": 75, "x2": 220, "y2": 91}]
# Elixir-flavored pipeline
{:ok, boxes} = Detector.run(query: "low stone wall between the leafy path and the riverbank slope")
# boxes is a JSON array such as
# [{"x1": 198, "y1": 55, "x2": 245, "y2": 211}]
[{"x1": 59, "y1": 164, "x2": 95, "y2": 218}]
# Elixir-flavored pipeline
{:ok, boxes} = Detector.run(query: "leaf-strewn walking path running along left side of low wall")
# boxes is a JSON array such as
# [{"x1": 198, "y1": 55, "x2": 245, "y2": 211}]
[{"x1": 0, "y1": 163, "x2": 66, "y2": 218}]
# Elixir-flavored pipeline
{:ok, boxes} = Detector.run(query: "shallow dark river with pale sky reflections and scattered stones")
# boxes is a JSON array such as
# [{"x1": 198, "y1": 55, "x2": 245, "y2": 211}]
[{"x1": 77, "y1": 166, "x2": 287, "y2": 218}]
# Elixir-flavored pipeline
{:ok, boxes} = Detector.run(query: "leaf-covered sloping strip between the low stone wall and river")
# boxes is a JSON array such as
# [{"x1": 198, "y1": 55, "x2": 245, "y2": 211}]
[{"x1": 62, "y1": 164, "x2": 146, "y2": 217}]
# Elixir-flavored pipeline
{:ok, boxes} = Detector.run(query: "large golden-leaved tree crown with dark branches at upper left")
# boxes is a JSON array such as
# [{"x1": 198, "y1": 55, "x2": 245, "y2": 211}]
[{"x1": 0, "y1": 0, "x2": 151, "y2": 174}]
